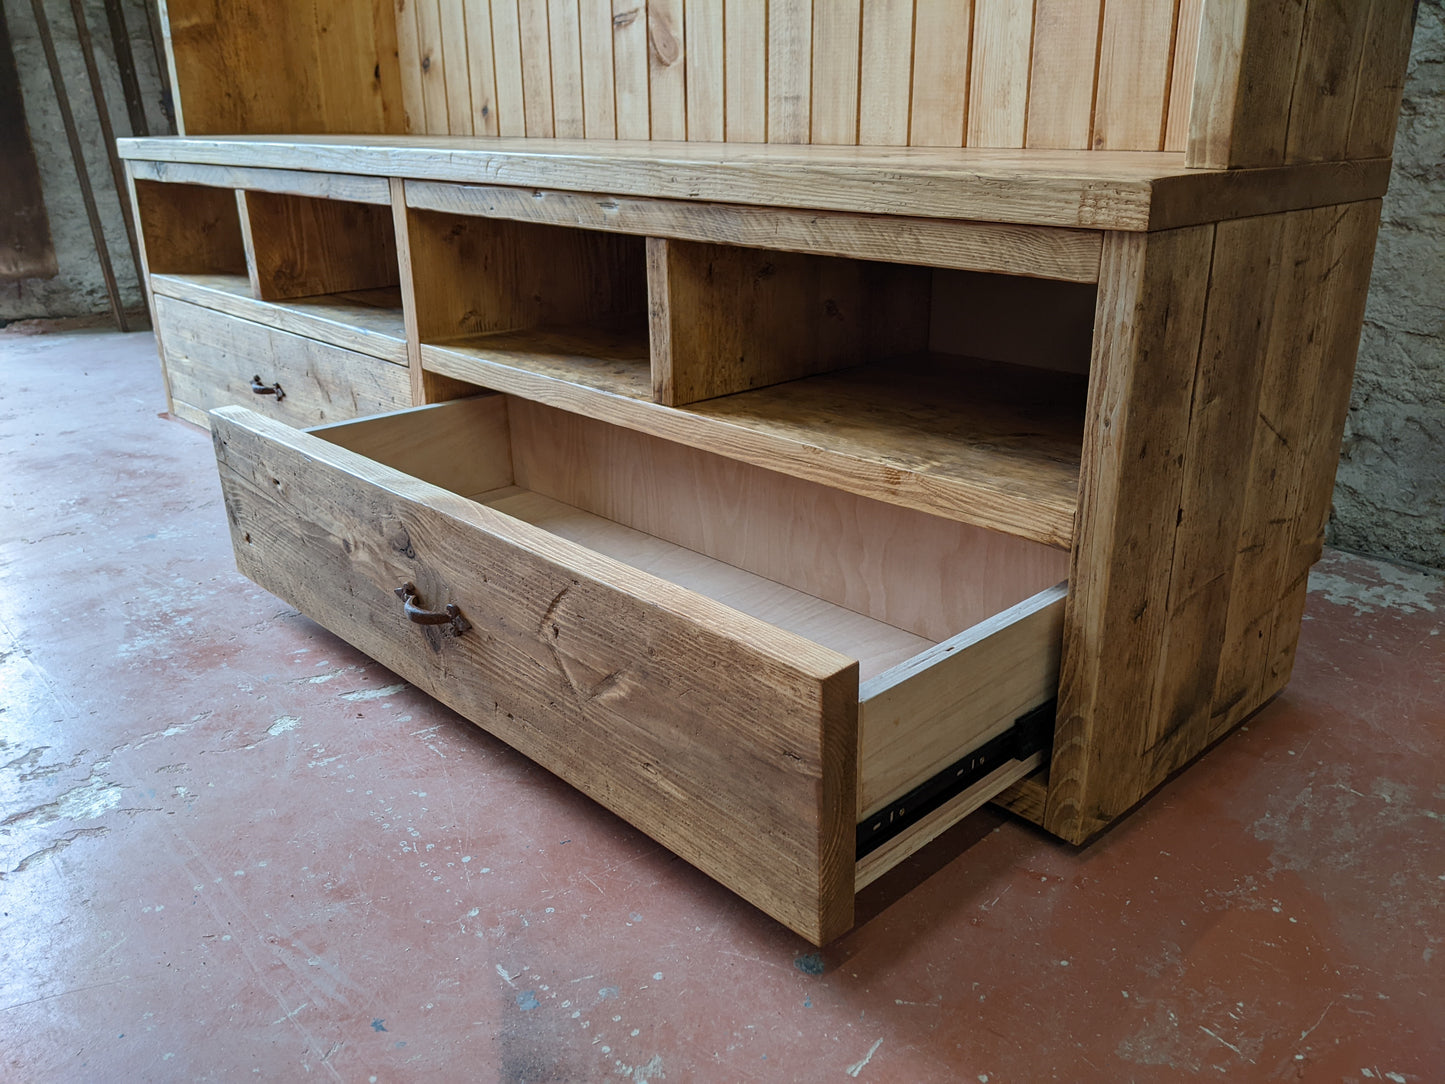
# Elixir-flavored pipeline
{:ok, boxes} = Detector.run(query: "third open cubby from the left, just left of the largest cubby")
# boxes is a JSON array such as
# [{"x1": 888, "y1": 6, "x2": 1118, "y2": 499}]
[{"x1": 407, "y1": 210, "x2": 652, "y2": 399}]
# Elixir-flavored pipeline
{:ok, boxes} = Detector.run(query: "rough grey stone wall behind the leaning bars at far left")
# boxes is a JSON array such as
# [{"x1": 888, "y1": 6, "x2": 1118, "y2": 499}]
[{"x1": 0, "y1": 0, "x2": 171, "y2": 322}]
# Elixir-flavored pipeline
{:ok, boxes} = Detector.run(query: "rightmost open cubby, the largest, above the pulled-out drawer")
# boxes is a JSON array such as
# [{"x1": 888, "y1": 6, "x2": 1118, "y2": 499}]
[{"x1": 649, "y1": 240, "x2": 1095, "y2": 548}]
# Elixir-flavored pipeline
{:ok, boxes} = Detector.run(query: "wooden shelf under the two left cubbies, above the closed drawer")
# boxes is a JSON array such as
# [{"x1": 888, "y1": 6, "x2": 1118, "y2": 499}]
[{"x1": 150, "y1": 275, "x2": 407, "y2": 366}]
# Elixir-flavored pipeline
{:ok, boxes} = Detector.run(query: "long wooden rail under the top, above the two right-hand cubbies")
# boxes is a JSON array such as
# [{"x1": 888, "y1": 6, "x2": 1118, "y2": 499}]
[{"x1": 406, "y1": 181, "x2": 1103, "y2": 282}]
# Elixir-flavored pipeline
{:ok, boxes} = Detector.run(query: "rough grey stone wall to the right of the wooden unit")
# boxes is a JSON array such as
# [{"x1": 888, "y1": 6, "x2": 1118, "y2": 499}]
[{"x1": 1329, "y1": 0, "x2": 1445, "y2": 568}]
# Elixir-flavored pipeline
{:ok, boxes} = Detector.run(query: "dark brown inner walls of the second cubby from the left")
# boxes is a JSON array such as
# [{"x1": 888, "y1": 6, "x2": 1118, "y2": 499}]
[{"x1": 241, "y1": 192, "x2": 397, "y2": 301}]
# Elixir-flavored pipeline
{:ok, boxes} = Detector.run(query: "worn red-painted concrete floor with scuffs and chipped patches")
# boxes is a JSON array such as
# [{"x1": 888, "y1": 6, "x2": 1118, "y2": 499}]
[{"x1": 0, "y1": 330, "x2": 1445, "y2": 1084}]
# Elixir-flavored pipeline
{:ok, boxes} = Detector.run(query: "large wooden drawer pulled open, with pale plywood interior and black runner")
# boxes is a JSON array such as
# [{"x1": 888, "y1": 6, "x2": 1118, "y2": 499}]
[{"x1": 211, "y1": 395, "x2": 1068, "y2": 944}]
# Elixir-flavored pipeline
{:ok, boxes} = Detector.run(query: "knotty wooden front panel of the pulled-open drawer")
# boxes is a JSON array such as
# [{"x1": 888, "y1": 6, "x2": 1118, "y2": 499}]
[{"x1": 212, "y1": 397, "x2": 857, "y2": 944}]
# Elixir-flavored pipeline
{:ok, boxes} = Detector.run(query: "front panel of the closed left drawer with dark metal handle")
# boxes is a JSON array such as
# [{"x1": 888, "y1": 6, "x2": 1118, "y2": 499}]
[{"x1": 155, "y1": 295, "x2": 412, "y2": 425}]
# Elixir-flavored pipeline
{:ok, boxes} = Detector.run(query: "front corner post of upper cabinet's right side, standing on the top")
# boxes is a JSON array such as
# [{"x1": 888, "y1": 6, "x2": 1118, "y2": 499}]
[{"x1": 1185, "y1": 0, "x2": 1305, "y2": 169}]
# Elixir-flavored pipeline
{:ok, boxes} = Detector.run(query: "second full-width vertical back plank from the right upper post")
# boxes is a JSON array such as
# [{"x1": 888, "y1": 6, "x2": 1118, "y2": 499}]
[{"x1": 1027, "y1": 0, "x2": 1103, "y2": 150}]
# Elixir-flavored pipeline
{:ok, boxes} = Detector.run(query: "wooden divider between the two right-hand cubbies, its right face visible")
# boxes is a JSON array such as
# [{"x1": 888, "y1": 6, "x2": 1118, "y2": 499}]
[{"x1": 647, "y1": 237, "x2": 929, "y2": 406}]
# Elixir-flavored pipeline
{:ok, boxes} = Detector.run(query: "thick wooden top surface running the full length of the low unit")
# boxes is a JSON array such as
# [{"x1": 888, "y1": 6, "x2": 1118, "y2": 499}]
[{"x1": 118, "y1": 136, "x2": 1390, "y2": 231}]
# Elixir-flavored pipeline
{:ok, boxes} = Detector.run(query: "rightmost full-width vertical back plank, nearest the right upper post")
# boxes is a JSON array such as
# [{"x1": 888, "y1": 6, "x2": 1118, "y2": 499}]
[{"x1": 1094, "y1": 0, "x2": 1178, "y2": 150}]
